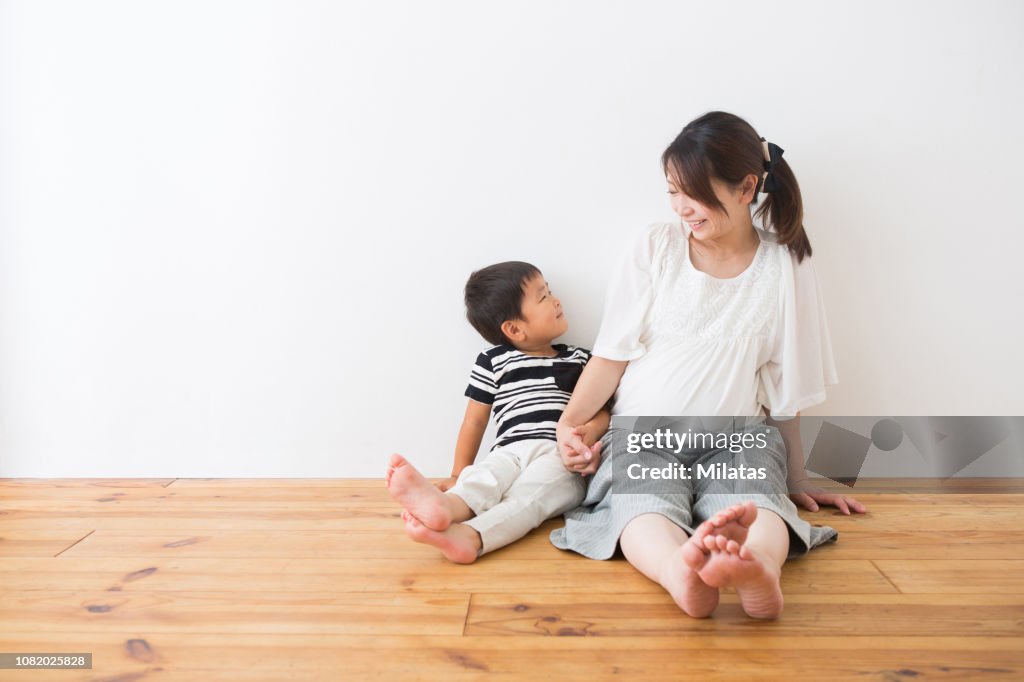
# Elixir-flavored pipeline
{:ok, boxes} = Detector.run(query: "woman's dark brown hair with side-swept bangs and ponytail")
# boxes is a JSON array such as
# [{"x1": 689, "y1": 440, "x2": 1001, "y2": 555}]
[{"x1": 662, "y1": 112, "x2": 811, "y2": 262}]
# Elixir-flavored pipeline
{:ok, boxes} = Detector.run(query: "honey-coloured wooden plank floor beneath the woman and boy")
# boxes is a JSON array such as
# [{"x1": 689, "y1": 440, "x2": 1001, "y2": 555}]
[{"x1": 0, "y1": 479, "x2": 1024, "y2": 682}]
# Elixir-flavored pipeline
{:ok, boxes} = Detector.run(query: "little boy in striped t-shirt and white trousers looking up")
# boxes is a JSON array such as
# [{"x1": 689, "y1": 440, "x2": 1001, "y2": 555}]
[{"x1": 385, "y1": 261, "x2": 610, "y2": 563}]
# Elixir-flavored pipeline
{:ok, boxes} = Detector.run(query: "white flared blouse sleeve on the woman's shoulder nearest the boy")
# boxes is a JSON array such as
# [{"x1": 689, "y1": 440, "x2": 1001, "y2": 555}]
[{"x1": 592, "y1": 224, "x2": 664, "y2": 360}]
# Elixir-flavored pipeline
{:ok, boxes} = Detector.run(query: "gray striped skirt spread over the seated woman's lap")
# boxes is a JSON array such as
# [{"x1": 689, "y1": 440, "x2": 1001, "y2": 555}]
[{"x1": 551, "y1": 424, "x2": 839, "y2": 559}]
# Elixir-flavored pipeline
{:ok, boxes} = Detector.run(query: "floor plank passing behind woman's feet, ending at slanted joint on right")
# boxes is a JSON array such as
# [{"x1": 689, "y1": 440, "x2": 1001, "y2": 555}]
[{"x1": 0, "y1": 556, "x2": 896, "y2": 595}]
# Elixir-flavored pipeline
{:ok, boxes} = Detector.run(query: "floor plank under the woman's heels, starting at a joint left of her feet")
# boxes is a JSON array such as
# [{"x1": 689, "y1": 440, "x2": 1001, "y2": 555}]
[{"x1": 465, "y1": 592, "x2": 1024, "y2": 646}]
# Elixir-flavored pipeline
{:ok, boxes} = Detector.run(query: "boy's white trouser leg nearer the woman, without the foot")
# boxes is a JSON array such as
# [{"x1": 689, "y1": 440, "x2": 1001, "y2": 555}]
[{"x1": 465, "y1": 441, "x2": 587, "y2": 554}]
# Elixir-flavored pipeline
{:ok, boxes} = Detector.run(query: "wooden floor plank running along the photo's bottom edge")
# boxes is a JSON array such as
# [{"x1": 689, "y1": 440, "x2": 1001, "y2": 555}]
[{"x1": 0, "y1": 624, "x2": 1024, "y2": 682}]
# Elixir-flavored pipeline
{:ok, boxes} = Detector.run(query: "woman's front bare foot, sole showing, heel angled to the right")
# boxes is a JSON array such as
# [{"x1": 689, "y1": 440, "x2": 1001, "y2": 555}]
[{"x1": 683, "y1": 503, "x2": 783, "y2": 619}]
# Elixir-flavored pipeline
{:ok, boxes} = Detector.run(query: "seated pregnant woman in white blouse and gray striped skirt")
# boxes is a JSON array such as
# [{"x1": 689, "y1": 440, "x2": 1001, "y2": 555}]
[{"x1": 551, "y1": 112, "x2": 866, "y2": 619}]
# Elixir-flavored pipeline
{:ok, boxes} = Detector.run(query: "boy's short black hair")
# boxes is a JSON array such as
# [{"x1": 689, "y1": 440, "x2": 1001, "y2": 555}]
[{"x1": 466, "y1": 260, "x2": 541, "y2": 346}]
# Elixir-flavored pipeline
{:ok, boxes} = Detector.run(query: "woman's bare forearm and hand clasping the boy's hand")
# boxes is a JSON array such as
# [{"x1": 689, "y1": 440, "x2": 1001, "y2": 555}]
[{"x1": 555, "y1": 355, "x2": 629, "y2": 474}]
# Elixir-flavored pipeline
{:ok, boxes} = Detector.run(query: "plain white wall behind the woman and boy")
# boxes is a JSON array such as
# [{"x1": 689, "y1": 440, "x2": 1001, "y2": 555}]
[{"x1": 0, "y1": 0, "x2": 1024, "y2": 477}]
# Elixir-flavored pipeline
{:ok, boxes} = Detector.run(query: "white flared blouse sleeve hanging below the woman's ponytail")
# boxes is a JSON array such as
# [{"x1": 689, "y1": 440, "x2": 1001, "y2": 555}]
[{"x1": 758, "y1": 252, "x2": 839, "y2": 417}]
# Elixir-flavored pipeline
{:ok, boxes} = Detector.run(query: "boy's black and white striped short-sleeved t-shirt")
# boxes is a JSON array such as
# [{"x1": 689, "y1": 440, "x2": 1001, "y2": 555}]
[{"x1": 465, "y1": 343, "x2": 590, "y2": 450}]
